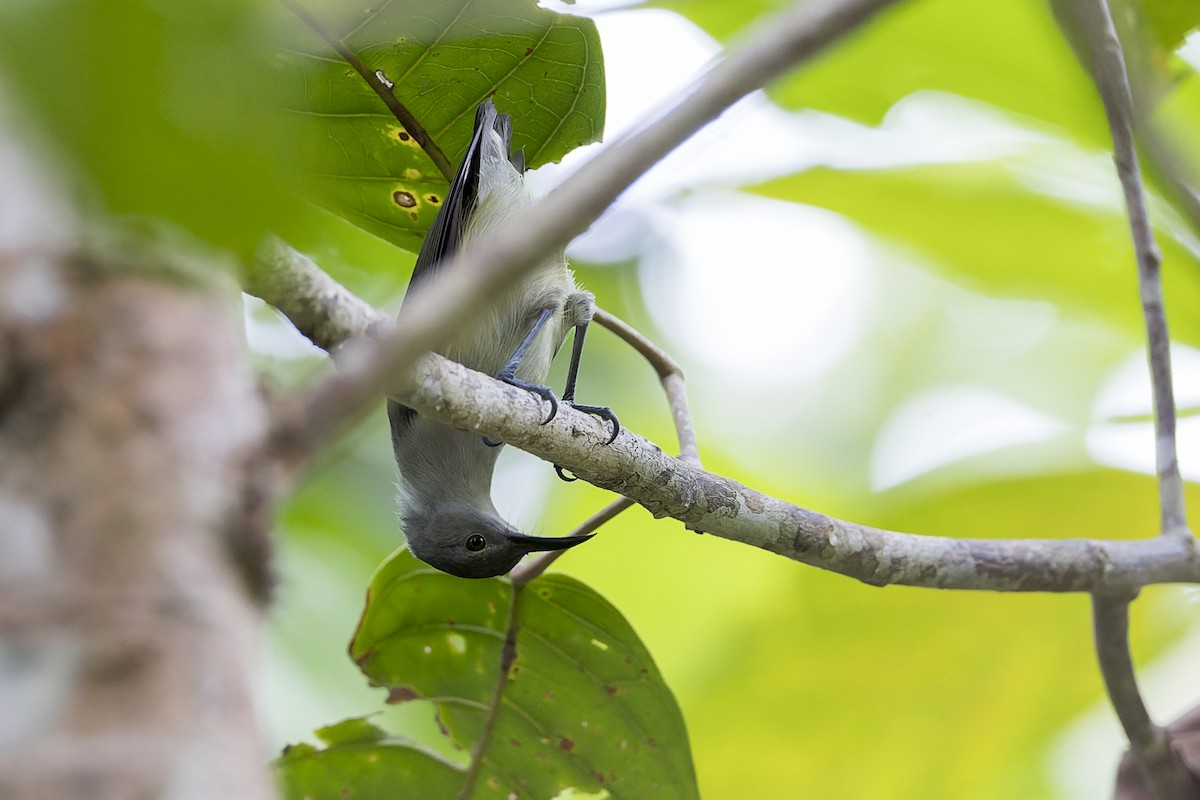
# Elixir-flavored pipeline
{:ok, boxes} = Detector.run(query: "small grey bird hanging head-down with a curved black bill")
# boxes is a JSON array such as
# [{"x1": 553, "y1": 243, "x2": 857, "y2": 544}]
[{"x1": 388, "y1": 100, "x2": 620, "y2": 578}]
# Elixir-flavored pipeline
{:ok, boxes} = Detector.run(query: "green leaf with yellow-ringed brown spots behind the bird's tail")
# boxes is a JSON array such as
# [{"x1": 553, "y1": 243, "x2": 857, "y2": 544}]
[{"x1": 280, "y1": 0, "x2": 605, "y2": 249}]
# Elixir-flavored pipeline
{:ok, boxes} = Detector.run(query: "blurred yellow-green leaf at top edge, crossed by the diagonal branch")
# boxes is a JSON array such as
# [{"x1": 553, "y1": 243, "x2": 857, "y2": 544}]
[{"x1": 655, "y1": 0, "x2": 1108, "y2": 146}]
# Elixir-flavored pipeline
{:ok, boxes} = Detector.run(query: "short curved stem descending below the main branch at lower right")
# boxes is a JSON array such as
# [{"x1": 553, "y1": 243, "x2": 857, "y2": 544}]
[{"x1": 1092, "y1": 595, "x2": 1196, "y2": 800}]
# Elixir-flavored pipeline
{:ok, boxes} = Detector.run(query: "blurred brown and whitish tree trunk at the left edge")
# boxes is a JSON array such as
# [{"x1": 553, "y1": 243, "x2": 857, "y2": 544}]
[{"x1": 0, "y1": 117, "x2": 272, "y2": 800}]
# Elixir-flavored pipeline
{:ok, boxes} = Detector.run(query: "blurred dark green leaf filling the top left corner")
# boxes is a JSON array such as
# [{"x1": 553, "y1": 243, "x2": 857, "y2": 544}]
[{"x1": 0, "y1": 0, "x2": 304, "y2": 253}]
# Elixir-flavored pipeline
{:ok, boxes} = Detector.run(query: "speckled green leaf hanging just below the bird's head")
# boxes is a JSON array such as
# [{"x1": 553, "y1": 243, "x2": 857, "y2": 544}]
[{"x1": 340, "y1": 551, "x2": 697, "y2": 798}]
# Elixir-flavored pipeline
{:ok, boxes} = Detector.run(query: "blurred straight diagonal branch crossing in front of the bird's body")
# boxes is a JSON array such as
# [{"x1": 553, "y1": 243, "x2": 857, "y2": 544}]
[{"x1": 285, "y1": 0, "x2": 896, "y2": 462}]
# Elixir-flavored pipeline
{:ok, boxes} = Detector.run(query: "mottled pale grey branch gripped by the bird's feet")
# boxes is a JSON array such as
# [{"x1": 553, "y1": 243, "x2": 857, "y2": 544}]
[{"x1": 243, "y1": 248, "x2": 1200, "y2": 594}]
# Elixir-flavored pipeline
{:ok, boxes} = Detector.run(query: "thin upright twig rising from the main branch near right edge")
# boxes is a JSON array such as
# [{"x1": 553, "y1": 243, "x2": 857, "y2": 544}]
[{"x1": 1075, "y1": 0, "x2": 1192, "y2": 537}]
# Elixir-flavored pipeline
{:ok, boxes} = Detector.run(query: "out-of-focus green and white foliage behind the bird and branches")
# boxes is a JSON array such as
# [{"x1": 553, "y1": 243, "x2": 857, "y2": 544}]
[{"x1": 0, "y1": 0, "x2": 1200, "y2": 800}]
